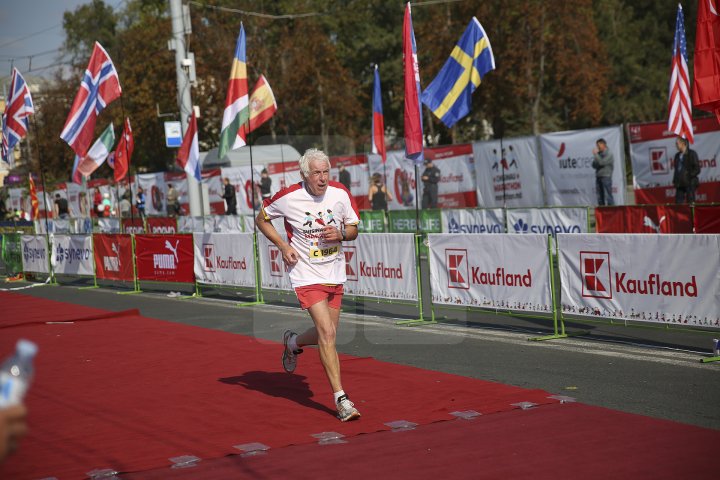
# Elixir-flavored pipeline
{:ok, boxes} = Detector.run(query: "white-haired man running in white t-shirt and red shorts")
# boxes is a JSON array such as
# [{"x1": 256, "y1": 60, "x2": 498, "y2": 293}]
[{"x1": 257, "y1": 148, "x2": 360, "y2": 422}]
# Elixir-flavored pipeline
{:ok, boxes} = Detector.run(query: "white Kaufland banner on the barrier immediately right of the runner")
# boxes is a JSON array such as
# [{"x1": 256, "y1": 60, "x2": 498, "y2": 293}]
[{"x1": 342, "y1": 233, "x2": 418, "y2": 300}]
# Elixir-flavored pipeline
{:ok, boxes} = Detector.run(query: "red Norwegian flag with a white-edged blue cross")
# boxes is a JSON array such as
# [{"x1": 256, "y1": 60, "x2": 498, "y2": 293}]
[{"x1": 60, "y1": 42, "x2": 122, "y2": 157}]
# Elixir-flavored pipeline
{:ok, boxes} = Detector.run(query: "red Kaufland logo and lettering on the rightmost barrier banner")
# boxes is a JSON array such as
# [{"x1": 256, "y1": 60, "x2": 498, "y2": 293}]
[{"x1": 580, "y1": 252, "x2": 698, "y2": 299}]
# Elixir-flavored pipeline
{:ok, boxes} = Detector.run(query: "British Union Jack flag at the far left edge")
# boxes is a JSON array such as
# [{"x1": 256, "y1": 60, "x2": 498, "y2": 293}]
[{"x1": 2, "y1": 68, "x2": 35, "y2": 167}]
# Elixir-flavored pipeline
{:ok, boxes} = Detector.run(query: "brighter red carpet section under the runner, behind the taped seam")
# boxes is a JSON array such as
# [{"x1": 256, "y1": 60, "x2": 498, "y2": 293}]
[{"x1": 0, "y1": 292, "x2": 555, "y2": 479}]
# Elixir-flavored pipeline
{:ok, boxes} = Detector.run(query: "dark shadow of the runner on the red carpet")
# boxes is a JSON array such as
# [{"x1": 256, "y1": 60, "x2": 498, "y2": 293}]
[{"x1": 218, "y1": 371, "x2": 337, "y2": 416}]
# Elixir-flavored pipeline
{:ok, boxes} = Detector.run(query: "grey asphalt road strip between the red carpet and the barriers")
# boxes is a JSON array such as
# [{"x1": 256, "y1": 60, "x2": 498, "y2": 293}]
[{"x1": 5, "y1": 283, "x2": 720, "y2": 429}]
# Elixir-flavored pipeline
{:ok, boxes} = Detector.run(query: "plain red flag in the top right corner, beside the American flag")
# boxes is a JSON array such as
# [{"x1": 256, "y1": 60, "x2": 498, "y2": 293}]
[{"x1": 693, "y1": 0, "x2": 720, "y2": 122}]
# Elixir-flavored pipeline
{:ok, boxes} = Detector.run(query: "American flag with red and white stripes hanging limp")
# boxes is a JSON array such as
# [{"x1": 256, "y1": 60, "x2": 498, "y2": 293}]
[{"x1": 668, "y1": 4, "x2": 693, "y2": 143}]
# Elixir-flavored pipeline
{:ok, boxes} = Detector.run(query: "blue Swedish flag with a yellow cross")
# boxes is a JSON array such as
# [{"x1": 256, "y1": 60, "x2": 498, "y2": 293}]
[{"x1": 422, "y1": 17, "x2": 495, "y2": 128}]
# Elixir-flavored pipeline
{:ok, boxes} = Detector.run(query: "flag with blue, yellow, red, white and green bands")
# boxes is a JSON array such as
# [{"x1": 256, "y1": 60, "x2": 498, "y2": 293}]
[{"x1": 218, "y1": 24, "x2": 250, "y2": 158}]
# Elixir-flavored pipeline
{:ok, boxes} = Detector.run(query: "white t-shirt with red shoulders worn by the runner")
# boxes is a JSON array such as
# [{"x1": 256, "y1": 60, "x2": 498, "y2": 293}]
[{"x1": 263, "y1": 182, "x2": 360, "y2": 288}]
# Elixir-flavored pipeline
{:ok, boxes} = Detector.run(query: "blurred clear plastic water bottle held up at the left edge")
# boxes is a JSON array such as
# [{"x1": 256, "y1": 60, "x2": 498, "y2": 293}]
[{"x1": 0, "y1": 339, "x2": 37, "y2": 408}]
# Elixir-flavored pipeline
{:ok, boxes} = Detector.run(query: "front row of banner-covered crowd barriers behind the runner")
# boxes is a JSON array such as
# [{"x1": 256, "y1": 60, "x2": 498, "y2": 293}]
[{"x1": 12, "y1": 225, "x2": 720, "y2": 356}]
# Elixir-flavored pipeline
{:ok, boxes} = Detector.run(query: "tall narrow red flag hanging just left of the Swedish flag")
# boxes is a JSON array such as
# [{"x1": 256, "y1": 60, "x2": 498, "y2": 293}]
[{"x1": 403, "y1": 2, "x2": 423, "y2": 163}]
